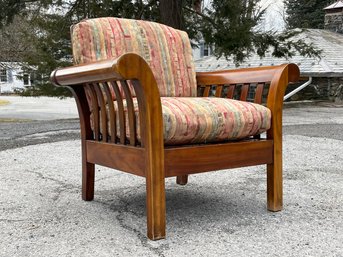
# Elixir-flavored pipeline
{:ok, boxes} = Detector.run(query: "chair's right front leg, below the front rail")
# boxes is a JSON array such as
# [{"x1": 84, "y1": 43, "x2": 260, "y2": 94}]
[{"x1": 267, "y1": 154, "x2": 283, "y2": 212}]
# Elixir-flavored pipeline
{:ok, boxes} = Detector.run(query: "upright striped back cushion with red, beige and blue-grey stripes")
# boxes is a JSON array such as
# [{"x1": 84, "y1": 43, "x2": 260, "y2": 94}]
[{"x1": 72, "y1": 18, "x2": 196, "y2": 96}]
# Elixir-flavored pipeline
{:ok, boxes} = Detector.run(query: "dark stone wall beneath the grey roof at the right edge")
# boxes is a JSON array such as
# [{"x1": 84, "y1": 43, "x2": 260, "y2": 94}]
[{"x1": 286, "y1": 77, "x2": 343, "y2": 103}]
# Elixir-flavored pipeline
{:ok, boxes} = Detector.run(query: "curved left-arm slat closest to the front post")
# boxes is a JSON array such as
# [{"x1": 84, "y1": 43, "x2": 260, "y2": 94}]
[{"x1": 121, "y1": 81, "x2": 137, "y2": 146}]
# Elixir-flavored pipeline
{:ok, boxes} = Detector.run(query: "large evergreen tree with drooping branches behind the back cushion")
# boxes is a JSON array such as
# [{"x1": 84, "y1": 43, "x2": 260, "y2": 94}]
[{"x1": 0, "y1": 0, "x2": 317, "y2": 95}]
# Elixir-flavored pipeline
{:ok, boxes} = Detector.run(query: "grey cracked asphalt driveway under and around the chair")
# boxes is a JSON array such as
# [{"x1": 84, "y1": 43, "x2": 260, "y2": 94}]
[{"x1": 0, "y1": 96, "x2": 343, "y2": 257}]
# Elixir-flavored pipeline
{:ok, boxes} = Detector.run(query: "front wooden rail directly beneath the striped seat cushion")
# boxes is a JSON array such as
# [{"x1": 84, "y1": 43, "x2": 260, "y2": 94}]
[{"x1": 165, "y1": 140, "x2": 273, "y2": 177}]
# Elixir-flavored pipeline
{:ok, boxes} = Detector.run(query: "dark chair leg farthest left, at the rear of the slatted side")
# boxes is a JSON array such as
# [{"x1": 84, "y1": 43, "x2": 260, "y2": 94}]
[{"x1": 82, "y1": 160, "x2": 95, "y2": 201}]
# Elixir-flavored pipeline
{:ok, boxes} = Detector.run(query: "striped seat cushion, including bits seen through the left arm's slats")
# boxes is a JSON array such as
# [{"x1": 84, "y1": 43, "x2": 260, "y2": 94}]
[{"x1": 94, "y1": 97, "x2": 271, "y2": 145}]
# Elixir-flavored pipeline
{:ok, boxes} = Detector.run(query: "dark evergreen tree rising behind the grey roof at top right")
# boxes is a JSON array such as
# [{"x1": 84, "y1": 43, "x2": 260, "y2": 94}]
[{"x1": 284, "y1": 0, "x2": 332, "y2": 29}]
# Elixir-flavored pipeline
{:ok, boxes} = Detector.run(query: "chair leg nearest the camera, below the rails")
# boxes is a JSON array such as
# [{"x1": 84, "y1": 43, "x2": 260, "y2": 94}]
[{"x1": 146, "y1": 170, "x2": 166, "y2": 240}]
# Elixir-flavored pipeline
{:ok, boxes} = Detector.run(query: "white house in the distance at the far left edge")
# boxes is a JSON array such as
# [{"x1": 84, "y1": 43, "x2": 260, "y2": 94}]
[{"x1": 0, "y1": 62, "x2": 31, "y2": 94}]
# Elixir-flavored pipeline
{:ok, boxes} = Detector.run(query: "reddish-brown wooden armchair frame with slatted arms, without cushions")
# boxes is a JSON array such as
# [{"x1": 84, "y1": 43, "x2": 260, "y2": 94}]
[{"x1": 51, "y1": 53, "x2": 299, "y2": 240}]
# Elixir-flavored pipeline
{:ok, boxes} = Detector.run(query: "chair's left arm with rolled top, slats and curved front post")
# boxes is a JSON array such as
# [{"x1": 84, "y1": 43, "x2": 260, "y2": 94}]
[{"x1": 51, "y1": 53, "x2": 163, "y2": 151}]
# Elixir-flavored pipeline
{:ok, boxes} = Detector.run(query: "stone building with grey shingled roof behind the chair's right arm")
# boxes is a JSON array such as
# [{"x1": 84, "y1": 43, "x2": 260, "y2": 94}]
[{"x1": 195, "y1": 0, "x2": 343, "y2": 103}]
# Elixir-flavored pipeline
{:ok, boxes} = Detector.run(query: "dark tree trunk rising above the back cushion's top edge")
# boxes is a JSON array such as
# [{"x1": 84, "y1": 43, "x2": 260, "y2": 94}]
[{"x1": 160, "y1": 0, "x2": 184, "y2": 30}]
